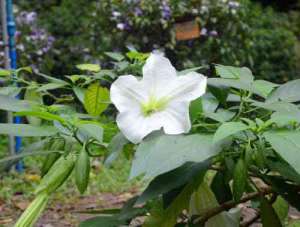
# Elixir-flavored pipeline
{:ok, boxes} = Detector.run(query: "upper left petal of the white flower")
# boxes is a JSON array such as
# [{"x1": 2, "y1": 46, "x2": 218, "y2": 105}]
[{"x1": 110, "y1": 75, "x2": 148, "y2": 112}]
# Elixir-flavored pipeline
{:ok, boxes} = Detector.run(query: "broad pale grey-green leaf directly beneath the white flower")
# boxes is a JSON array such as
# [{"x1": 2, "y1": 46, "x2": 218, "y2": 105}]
[{"x1": 130, "y1": 134, "x2": 221, "y2": 178}]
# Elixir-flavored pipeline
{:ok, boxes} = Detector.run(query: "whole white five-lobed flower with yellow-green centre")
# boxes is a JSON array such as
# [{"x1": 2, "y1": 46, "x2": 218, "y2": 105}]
[{"x1": 110, "y1": 54, "x2": 207, "y2": 143}]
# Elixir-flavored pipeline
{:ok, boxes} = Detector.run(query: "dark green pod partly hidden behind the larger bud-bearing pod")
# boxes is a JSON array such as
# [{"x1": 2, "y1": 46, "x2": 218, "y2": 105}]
[{"x1": 41, "y1": 139, "x2": 65, "y2": 176}]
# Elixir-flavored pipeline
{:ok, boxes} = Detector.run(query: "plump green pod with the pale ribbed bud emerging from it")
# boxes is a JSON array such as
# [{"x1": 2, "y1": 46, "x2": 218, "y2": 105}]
[{"x1": 35, "y1": 155, "x2": 75, "y2": 194}]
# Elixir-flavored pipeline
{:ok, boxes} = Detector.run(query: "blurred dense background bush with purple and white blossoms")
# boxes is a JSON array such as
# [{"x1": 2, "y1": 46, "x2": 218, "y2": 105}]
[{"x1": 17, "y1": 0, "x2": 297, "y2": 81}]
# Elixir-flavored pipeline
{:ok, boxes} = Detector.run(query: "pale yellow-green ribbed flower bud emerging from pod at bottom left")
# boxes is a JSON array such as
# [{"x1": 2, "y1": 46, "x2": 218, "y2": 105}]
[{"x1": 15, "y1": 192, "x2": 49, "y2": 227}]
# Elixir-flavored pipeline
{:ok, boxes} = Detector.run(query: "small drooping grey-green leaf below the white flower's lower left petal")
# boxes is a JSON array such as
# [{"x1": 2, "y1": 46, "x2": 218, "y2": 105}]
[{"x1": 104, "y1": 132, "x2": 129, "y2": 167}]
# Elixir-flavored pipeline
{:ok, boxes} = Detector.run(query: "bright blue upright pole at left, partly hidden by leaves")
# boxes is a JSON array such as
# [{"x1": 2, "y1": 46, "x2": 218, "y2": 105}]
[{"x1": 6, "y1": 0, "x2": 24, "y2": 172}]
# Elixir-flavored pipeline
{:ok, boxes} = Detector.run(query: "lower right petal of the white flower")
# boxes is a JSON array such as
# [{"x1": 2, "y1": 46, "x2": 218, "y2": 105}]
[{"x1": 161, "y1": 102, "x2": 191, "y2": 135}]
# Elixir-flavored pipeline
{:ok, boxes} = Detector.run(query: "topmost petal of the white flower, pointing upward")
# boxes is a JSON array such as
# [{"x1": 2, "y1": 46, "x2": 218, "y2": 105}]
[{"x1": 143, "y1": 54, "x2": 176, "y2": 94}]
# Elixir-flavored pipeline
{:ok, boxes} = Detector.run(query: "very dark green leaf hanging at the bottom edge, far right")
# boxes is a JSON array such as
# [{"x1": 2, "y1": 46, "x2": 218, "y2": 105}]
[{"x1": 260, "y1": 198, "x2": 282, "y2": 227}]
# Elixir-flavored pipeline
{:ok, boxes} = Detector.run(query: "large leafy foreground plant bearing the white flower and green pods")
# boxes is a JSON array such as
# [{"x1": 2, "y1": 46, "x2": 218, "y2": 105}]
[{"x1": 0, "y1": 51, "x2": 300, "y2": 227}]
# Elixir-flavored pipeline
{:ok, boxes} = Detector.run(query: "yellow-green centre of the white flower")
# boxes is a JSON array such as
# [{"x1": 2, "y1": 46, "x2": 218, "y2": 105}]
[{"x1": 141, "y1": 96, "x2": 168, "y2": 117}]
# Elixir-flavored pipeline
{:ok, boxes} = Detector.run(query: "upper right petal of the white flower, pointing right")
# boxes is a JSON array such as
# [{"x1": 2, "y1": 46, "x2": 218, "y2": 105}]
[{"x1": 161, "y1": 72, "x2": 207, "y2": 101}]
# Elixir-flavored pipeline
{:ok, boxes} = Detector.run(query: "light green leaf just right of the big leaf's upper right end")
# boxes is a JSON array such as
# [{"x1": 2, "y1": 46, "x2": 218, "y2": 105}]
[{"x1": 213, "y1": 122, "x2": 249, "y2": 143}]
